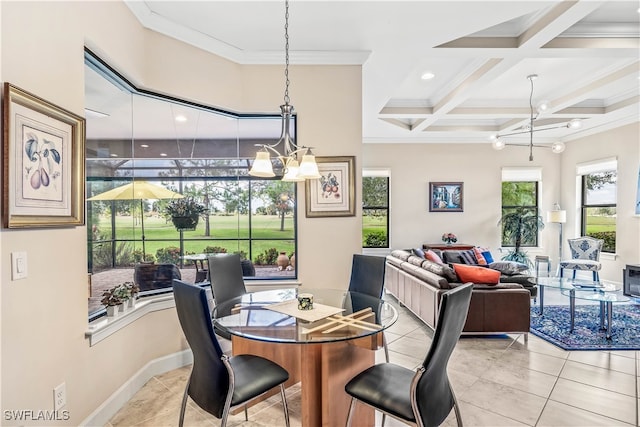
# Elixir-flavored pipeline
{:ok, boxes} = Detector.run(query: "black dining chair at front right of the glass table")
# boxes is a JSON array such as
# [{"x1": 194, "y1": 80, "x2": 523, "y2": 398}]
[{"x1": 345, "y1": 283, "x2": 473, "y2": 427}]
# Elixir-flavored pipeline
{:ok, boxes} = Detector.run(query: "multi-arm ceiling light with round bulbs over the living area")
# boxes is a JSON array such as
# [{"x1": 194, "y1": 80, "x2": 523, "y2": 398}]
[{"x1": 491, "y1": 74, "x2": 582, "y2": 162}]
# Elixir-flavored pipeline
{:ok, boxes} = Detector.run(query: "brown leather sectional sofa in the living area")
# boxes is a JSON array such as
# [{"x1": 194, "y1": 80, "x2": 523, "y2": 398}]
[{"x1": 385, "y1": 250, "x2": 536, "y2": 339}]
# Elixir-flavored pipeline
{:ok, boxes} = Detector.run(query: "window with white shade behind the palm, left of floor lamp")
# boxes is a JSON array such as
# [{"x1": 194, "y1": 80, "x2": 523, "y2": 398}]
[{"x1": 501, "y1": 168, "x2": 541, "y2": 247}]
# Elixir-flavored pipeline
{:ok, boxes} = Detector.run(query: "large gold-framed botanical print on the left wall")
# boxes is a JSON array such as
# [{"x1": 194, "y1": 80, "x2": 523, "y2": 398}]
[{"x1": 2, "y1": 83, "x2": 85, "y2": 228}]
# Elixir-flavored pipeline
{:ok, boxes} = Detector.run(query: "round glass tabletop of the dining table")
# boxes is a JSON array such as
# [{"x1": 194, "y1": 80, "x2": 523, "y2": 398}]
[{"x1": 213, "y1": 288, "x2": 398, "y2": 344}]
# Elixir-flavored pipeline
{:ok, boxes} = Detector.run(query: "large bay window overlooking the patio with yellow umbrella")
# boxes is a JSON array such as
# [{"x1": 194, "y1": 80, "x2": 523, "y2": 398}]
[{"x1": 85, "y1": 51, "x2": 297, "y2": 319}]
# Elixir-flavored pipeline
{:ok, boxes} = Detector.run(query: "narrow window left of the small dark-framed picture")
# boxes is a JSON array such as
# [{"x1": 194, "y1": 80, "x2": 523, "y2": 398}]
[{"x1": 362, "y1": 170, "x2": 389, "y2": 248}]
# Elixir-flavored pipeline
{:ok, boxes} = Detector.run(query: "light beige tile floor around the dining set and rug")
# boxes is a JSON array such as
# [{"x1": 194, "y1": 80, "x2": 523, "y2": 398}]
[{"x1": 107, "y1": 297, "x2": 640, "y2": 427}]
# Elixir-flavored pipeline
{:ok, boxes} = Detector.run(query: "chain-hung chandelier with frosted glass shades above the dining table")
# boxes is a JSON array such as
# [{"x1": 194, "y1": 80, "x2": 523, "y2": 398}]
[{"x1": 249, "y1": 0, "x2": 320, "y2": 182}]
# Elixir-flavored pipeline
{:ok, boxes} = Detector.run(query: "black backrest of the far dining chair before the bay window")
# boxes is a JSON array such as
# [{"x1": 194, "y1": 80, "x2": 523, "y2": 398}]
[{"x1": 208, "y1": 254, "x2": 247, "y2": 316}]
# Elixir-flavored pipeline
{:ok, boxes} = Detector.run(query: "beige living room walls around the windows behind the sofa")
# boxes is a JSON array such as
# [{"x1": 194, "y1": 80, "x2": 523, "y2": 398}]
[{"x1": 363, "y1": 123, "x2": 640, "y2": 282}]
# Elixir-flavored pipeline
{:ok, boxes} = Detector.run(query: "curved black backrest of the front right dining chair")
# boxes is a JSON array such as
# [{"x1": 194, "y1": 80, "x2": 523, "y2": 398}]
[{"x1": 416, "y1": 283, "x2": 473, "y2": 426}]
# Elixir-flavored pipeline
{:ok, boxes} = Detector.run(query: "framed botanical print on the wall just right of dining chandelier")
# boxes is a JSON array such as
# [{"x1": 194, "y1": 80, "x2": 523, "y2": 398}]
[{"x1": 305, "y1": 156, "x2": 356, "y2": 218}]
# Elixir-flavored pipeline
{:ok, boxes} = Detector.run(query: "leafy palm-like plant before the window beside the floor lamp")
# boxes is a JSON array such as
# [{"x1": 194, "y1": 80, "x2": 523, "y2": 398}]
[{"x1": 498, "y1": 206, "x2": 544, "y2": 267}]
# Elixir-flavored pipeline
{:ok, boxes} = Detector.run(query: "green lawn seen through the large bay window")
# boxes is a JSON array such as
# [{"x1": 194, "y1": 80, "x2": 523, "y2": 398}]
[{"x1": 92, "y1": 215, "x2": 294, "y2": 259}]
